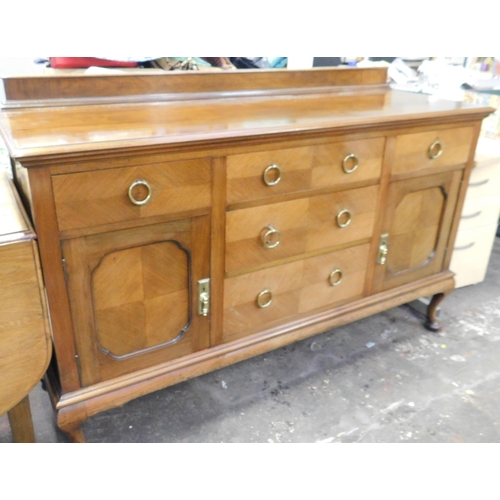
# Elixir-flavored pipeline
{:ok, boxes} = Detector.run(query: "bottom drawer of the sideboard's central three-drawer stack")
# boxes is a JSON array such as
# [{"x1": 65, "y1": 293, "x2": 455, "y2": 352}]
[{"x1": 223, "y1": 244, "x2": 369, "y2": 342}]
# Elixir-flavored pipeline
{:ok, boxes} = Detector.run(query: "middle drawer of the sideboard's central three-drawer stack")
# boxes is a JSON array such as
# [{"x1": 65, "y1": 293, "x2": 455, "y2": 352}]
[{"x1": 226, "y1": 186, "x2": 378, "y2": 272}]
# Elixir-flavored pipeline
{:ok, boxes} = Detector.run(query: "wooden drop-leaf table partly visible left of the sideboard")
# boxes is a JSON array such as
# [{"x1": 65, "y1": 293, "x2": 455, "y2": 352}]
[{"x1": 0, "y1": 173, "x2": 52, "y2": 443}]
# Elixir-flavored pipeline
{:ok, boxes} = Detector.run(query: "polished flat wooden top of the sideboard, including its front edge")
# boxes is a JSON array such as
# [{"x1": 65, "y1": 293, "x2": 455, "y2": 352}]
[{"x1": 0, "y1": 66, "x2": 492, "y2": 166}]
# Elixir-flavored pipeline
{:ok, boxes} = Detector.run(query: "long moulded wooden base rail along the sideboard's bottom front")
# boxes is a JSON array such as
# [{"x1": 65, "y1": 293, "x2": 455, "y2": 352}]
[{"x1": 57, "y1": 271, "x2": 455, "y2": 416}]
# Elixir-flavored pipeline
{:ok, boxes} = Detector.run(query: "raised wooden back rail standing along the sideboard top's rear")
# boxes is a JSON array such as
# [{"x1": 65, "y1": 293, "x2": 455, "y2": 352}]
[{"x1": 3, "y1": 68, "x2": 387, "y2": 104}]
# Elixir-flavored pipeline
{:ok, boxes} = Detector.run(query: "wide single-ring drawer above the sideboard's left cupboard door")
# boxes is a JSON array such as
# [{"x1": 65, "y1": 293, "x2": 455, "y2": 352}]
[{"x1": 52, "y1": 159, "x2": 211, "y2": 231}]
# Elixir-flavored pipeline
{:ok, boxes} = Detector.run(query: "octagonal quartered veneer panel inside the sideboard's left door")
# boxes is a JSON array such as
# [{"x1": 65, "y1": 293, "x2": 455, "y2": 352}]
[{"x1": 92, "y1": 241, "x2": 189, "y2": 358}]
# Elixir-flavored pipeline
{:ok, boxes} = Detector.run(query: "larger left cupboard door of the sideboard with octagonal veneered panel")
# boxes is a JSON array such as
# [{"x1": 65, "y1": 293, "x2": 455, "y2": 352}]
[{"x1": 62, "y1": 217, "x2": 210, "y2": 386}]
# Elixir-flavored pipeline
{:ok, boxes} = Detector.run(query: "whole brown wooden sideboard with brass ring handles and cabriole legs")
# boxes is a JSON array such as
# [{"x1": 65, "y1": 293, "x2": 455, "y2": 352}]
[{"x1": 0, "y1": 69, "x2": 492, "y2": 441}]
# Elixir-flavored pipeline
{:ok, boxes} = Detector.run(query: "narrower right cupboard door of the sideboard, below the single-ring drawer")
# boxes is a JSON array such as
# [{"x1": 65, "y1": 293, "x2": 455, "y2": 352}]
[{"x1": 373, "y1": 170, "x2": 462, "y2": 292}]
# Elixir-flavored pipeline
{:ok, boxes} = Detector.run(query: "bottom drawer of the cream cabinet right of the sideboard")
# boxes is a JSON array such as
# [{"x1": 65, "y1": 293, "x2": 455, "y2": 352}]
[{"x1": 450, "y1": 224, "x2": 497, "y2": 288}]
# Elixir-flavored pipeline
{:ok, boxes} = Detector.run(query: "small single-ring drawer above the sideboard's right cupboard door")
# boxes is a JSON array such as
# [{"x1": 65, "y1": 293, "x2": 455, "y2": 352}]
[{"x1": 392, "y1": 127, "x2": 474, "y2": 175}]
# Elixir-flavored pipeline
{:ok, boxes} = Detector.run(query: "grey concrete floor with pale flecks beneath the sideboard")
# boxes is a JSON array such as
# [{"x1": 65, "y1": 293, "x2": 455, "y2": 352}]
[{"x1": 0, "y1": 238, "x2": 500, "y2": 443}]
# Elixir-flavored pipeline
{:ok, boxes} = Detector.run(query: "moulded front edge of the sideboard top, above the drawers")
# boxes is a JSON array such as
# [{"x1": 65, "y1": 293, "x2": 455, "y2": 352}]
[{"x1": 10, "y1": 108, "x2": 492, "y2": 168}]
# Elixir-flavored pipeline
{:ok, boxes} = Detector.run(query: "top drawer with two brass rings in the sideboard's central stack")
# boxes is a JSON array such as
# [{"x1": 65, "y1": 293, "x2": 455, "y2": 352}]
[{"x1": 227, "y1": 137, "x2": 385, "y2": 204}]
